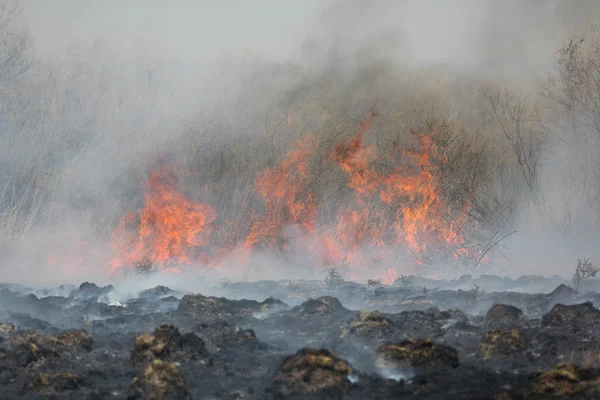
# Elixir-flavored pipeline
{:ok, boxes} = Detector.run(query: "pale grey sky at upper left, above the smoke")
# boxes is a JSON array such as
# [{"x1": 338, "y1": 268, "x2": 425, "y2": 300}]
[{"x1": 23, "y1": 0, "x2": 330, "y2": 60}]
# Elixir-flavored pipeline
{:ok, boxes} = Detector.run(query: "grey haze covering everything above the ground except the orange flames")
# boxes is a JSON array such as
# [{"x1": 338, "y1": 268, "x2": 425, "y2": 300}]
[{"x1": 0, "y1": 0, "x2": 600, "y2": 283}]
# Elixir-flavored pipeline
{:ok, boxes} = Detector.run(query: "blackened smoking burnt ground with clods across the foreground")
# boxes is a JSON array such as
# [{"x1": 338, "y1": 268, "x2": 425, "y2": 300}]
[{"x1": 0, "y1": 276, "x2": 600, "y2": 399}]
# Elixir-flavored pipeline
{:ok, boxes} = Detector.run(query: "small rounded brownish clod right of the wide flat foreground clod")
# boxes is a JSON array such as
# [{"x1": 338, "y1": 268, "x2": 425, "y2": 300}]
[{"x1": 478, "y1": 329, "x2": 527, "y2": 360}]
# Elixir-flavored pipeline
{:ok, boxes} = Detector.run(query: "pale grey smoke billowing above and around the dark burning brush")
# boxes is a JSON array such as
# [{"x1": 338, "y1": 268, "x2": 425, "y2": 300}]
[{"x1": 0, "y1": 0, "x2": 600, "y2": 285}]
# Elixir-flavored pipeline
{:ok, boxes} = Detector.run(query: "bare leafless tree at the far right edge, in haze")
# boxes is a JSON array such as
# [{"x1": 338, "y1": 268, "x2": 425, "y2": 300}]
[{"x1": 542, "y1": 31, "x2": 600, "y2": 236}]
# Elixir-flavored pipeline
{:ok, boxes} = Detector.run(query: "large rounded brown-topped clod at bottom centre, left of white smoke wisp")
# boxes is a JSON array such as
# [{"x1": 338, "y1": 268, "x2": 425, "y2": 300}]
[{"x1": 269, "y1": 348, "x2": 352, "y2": 396}]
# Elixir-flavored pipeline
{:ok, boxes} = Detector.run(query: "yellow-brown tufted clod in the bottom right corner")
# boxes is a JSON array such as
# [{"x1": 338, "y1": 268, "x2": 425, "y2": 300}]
[{"x1": 527, "y1": 363, "x2": 600, "y2": 399}]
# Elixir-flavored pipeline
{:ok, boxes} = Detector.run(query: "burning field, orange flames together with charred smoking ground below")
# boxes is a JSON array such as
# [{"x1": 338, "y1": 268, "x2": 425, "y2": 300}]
[{"x1": 0, "y1": 108, "x2": 600, "y2": 400}]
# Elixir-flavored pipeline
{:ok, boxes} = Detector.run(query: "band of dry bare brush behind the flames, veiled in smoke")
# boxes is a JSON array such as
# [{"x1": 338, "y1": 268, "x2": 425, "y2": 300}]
[{"x1": 0, "y1": 0, "x2": 600, "y2": 278}]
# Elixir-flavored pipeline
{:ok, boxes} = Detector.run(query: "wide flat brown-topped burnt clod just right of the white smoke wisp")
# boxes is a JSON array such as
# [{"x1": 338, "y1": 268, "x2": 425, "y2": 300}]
[{"x1": 376, "y1": 338, "x2": 458, "y2": 369}]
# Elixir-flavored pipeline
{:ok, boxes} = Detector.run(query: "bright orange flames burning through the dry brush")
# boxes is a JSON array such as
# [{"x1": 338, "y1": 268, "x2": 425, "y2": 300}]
[{"x1": 108, "y1": 114, "x2": 478, "y2": 283}]
